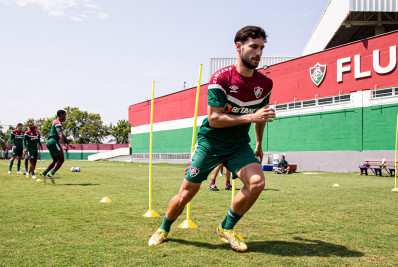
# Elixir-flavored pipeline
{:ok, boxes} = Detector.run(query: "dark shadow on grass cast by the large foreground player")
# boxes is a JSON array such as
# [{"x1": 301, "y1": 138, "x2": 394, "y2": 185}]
[{"x1": 168, "y1": 237, "x2": 365, "y2": 257}]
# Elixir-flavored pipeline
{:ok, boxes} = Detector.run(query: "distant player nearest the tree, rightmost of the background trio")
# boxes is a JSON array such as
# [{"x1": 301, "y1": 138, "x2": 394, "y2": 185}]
[{"x1": 40, "y1": 110, "x2": 73, "y2": 184}]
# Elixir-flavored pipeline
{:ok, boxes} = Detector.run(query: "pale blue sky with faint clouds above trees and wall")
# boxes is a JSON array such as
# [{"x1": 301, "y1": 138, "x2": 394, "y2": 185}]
[{"x1": 0, "y1": 0, "x2": 329, "y2": 125}]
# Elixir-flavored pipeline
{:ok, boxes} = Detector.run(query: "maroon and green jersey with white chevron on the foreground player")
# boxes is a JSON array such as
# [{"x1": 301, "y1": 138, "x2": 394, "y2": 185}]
[{"x1": 198, "y1": 65, "x2": 272, "y2": 144}]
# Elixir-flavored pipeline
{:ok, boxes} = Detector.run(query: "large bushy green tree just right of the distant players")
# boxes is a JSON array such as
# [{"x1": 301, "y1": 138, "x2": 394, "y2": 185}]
[{"x1": 62, "y1": 107, "x2": 109, "y2": 144}]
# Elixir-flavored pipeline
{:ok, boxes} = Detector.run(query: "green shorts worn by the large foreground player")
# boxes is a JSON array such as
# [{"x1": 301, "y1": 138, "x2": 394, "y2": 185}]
[{"x1": 185, "y1": 137, "x2": 260, "y2": 183}]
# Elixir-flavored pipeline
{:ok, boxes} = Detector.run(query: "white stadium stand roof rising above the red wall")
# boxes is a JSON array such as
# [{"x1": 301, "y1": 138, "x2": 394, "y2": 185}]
[{"x1": 302, "y1": 0, "x2": 398, "y2": 56}]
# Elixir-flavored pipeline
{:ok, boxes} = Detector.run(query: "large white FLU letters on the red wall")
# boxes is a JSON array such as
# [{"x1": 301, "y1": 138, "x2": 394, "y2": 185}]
[{"x1": 337, "y1": 45, "x2": 397, "y2": 82}]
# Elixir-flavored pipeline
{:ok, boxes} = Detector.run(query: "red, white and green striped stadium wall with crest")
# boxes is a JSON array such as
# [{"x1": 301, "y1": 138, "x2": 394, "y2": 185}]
[{"x1": 129, "y1": 32, "x2": 398, "y2": 172}]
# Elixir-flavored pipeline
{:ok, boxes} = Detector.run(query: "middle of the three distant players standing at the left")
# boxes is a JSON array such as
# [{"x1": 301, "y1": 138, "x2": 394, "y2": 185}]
[{"x1": 23, "y1": 121, "x2": 43, "y2": 179}]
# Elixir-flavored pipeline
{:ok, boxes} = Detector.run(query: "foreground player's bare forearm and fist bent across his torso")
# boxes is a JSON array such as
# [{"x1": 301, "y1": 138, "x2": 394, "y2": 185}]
[{"x1": 207, "y1": 106, "x2": 275, "y2": 128}]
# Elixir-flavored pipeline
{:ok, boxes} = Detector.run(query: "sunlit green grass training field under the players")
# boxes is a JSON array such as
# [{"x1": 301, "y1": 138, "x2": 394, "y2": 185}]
[{"x1": 0, "y1": 161, "x2": 398, "y2": 266}]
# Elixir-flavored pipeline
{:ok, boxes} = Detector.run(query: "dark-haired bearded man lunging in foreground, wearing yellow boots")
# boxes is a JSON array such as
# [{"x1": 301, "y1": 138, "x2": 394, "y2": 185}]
[{"x1": 148, "y1": 26, "x2": 275, "y2": 252}]
